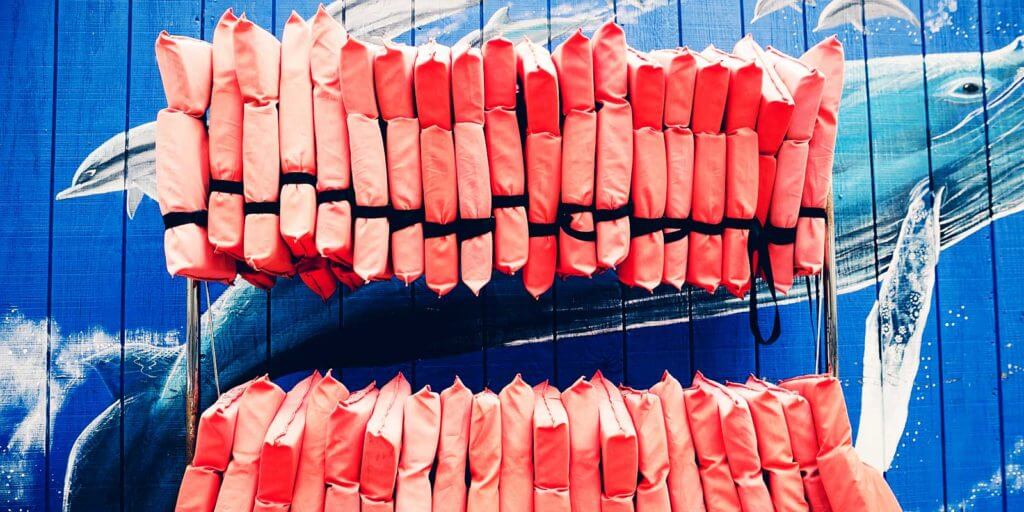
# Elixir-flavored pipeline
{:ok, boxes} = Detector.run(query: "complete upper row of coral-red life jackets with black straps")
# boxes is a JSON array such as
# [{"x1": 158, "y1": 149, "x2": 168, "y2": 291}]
[{"x1": 149, "y1": 7, "x2": 844, "y2": 342}]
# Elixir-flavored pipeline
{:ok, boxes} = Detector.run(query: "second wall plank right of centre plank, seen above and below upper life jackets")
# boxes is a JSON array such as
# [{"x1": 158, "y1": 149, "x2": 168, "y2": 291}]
[{"x1": 616, "y1": 1, "x2": 691, "y2": 388}]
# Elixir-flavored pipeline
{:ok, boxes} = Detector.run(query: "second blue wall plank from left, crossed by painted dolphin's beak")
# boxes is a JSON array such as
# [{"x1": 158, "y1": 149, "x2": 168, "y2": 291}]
[{"x1": 47, "y1": 1, "x2": 129, "y2": 510}]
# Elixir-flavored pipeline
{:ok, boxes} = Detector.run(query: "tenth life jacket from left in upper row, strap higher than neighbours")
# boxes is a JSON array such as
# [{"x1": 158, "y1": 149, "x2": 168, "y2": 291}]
[{"x1": 482, "y1": 38, "x2": 529, "y2": 275}]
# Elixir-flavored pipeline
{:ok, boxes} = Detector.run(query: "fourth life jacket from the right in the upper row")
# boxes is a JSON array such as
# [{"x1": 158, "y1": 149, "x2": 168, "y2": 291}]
[{"x1": 702, "y1": 46, "x2": 763, "y2": 297}]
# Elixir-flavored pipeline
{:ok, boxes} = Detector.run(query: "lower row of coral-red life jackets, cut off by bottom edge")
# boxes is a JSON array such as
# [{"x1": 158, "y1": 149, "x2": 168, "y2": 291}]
[{"x1": 176, "y1": 372, "x2": 900, "y2": 512}]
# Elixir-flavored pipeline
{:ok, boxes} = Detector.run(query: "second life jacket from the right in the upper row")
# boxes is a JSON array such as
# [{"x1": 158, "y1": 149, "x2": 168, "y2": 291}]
[{"x1": 765, "y1": 47, "x2": 824, "y2": 293}]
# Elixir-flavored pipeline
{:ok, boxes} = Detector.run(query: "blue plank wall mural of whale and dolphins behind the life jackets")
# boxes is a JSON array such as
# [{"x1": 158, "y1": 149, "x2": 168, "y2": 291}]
[{"x1": 0, "y1": 0, "x2": 1024, "y2": 511}]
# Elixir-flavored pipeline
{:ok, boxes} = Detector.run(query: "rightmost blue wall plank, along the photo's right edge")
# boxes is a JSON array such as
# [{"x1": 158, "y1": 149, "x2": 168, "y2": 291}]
[{"x1": 983, "y1": 0, "x2": 1024, "y2": 510}]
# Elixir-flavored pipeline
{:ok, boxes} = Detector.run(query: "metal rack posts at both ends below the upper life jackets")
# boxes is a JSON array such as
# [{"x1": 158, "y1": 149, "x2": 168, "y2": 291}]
[{"x1": 185, "y1": 191, "x2": 839, "y2": 461}]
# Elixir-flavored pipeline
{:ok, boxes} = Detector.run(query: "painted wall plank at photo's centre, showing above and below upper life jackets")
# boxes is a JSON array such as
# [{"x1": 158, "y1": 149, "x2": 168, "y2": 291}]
[{"x1": 481, "y1": 0, "x2": 558, "y2": 390}]
